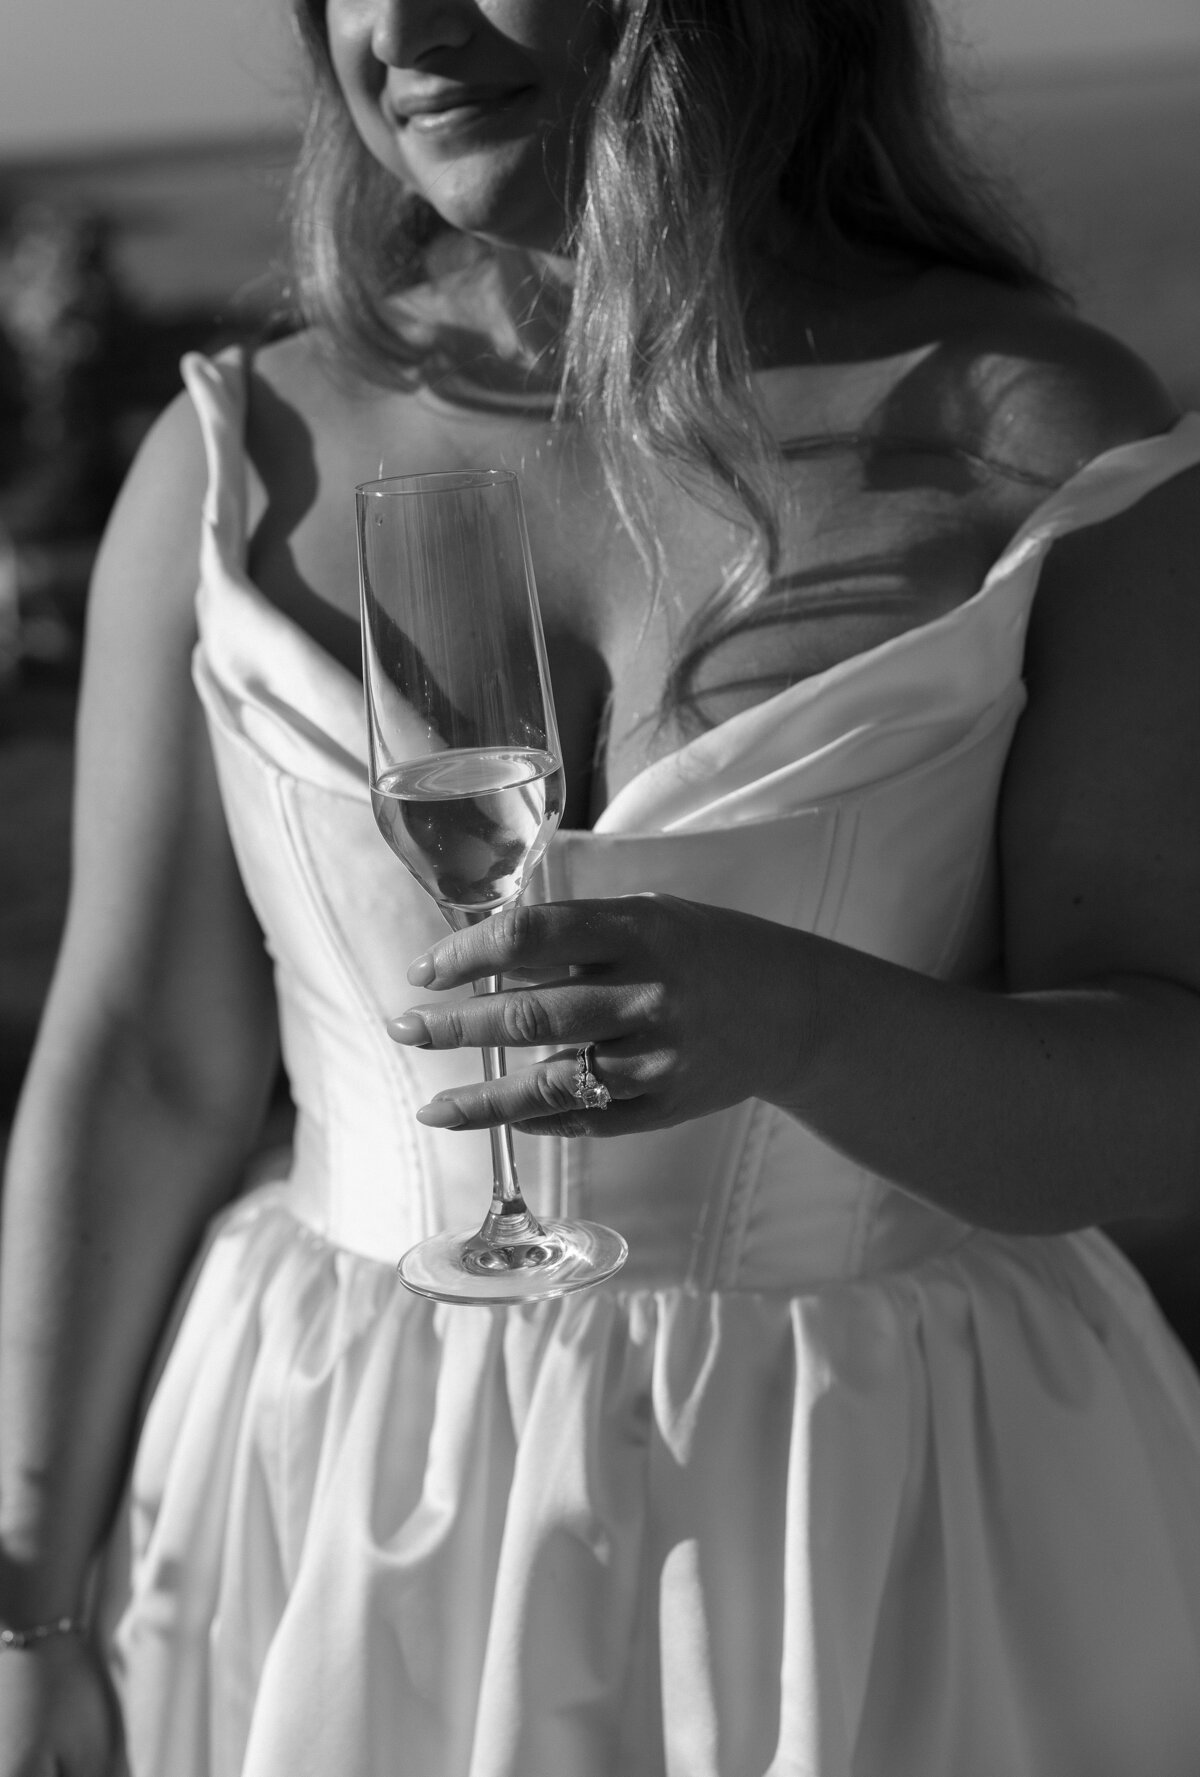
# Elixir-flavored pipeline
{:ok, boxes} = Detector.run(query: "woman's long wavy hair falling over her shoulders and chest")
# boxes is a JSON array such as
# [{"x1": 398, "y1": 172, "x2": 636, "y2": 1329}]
[{"x1": 292, "y1": 0, "x2": 1054, "y2": 714}]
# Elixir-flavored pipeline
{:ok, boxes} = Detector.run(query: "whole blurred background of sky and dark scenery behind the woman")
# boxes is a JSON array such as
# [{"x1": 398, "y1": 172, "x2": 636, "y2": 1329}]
[{"x1": 0, "y1": 0, "x2": 1200, "y2": 1356}]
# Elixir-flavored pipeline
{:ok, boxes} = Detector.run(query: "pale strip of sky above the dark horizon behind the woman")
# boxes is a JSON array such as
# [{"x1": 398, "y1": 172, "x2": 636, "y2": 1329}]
[{"x1": 0, "y1": 0, "x2": 1200, "y2": 156}]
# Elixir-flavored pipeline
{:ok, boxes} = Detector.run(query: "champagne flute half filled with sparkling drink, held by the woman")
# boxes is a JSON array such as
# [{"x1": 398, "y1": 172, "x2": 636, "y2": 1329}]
[{"x1": 356, "y1": 469, "x2": 628, "y2": 1303}]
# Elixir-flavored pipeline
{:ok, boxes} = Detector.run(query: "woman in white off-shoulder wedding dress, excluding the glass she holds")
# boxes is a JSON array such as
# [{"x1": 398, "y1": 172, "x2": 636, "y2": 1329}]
[{"x1": 0, "y1": 0, "x2": 1200, "y2": 1777}]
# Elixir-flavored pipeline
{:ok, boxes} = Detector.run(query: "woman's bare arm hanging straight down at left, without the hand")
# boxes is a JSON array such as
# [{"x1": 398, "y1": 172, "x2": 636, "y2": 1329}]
[{"x1": 0, "y1": 402, "x2": 276, "y2": 1634}]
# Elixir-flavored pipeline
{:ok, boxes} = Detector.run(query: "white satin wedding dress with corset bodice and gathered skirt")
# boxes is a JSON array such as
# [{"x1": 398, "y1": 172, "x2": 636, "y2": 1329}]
[{"x1": 100, "y1": 359, "x2": 1200, "y2": 1777}]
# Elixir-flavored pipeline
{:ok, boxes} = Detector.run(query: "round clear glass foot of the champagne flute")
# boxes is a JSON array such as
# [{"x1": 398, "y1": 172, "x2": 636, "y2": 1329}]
[{"x1": 396, "y1": 1221, "x2": 629, "y2": 1306}]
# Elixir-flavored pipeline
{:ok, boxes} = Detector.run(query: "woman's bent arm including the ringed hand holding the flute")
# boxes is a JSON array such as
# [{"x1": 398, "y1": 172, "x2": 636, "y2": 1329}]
[{"x1": 382, "y1": 376, "x2": 1200, "y2": 1231}]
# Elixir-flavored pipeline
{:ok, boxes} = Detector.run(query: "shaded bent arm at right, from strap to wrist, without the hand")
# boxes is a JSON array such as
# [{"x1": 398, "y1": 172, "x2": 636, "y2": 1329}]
[{"x1": 771, "y1": 435, "x2": 1200, "y2": 1231}]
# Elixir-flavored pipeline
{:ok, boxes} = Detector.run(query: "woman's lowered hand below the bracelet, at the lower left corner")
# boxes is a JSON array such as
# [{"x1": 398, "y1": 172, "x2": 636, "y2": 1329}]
[{"x1": 0, "y1": 1635, "x2": 117, "y2": 1777}]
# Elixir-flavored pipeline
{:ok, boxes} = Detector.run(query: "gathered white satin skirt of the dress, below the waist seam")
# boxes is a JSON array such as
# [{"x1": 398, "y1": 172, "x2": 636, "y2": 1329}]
[{"x1": 110, "y1": 1187, "x2": 1200, "y2": 1777}]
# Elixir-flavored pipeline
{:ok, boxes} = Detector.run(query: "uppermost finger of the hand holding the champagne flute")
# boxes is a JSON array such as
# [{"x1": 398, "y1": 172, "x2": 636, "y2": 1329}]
[{"x1": 409, "y1": 896, "x2": 656, "y2": 988}]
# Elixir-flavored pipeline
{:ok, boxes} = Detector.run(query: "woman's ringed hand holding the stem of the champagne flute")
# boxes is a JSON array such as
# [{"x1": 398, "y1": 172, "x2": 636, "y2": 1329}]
[{"x1": 388, "y1": 894, "x2": 811, "y2": 1136}]
